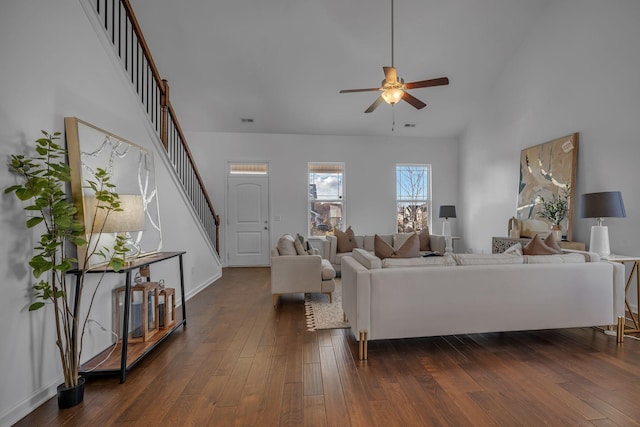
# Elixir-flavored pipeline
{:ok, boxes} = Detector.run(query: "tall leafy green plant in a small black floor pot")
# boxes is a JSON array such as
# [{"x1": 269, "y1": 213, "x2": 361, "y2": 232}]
[{"x1": 5, "y1": 131, "x2": 127, "y2": 408}]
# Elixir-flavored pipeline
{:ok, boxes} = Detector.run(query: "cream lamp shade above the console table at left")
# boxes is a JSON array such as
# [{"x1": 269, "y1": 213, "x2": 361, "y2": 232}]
[{"x1": 85, "y1": 194, "x2": 145, "y2": 233}]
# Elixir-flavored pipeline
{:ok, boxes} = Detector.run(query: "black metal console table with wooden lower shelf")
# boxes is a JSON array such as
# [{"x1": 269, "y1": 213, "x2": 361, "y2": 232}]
[{"x1": 69, "y1": 252, "x2": 187, "y2": 383}]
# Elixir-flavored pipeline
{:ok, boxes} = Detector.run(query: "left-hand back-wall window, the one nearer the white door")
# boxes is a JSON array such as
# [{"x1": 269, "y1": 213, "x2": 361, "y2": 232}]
[{"x1": 309, "y1": 163, "x2": 344, "y2": 236}]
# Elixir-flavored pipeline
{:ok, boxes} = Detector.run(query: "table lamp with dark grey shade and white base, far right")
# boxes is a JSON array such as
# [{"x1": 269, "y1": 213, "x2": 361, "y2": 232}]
[{"x1": 580, "y1": 191, "x2": 626, "y2": 257}]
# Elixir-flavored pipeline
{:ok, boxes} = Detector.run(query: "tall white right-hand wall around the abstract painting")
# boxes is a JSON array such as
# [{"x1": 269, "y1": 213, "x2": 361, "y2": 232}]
[{"x1": 460, "y1": 0, "x2": 640, "y2": 255}]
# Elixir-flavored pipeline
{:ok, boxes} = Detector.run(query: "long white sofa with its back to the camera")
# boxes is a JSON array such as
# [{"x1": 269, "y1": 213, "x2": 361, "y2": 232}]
[{"x1": 342, "y1": 249, "x2": 625, "y2": 359}]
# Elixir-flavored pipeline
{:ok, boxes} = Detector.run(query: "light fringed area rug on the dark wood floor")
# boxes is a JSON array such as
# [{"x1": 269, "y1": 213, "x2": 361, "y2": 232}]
[{"x1": 304, "y1": 279, "x2": 349, "y2": 331}]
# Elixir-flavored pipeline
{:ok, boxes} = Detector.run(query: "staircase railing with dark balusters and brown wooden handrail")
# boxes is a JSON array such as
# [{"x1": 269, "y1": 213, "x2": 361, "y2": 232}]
[{"x1": 86, "y1": 0, "x2": 220, "y2": 254}]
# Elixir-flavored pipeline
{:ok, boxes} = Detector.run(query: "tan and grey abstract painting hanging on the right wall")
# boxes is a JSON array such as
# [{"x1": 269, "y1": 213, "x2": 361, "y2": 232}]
[{"x1": 517, "y1": 133, "x2": 578, "y2": 241}]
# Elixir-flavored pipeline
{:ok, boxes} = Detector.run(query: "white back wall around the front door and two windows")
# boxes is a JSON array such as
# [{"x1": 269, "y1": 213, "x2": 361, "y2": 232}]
[{"x1": 187, "y1": 132, "x2": 462, "y2": 264}]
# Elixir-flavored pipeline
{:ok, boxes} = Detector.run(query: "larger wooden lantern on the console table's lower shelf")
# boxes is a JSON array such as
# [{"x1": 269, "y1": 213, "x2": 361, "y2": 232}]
[{"x1": 116, "y1": 282, "x2": 160, "y2": 342}]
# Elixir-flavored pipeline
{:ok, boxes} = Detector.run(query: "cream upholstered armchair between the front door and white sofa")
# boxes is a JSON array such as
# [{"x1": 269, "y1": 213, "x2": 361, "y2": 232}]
[{"x1": 271, "y1": 235, "x2": 336, "y2": 307}]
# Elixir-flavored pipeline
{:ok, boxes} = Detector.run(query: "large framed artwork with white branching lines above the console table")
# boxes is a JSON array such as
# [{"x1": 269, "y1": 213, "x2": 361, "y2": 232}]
[{"x1": 64, "y1": 117, "x2": 162, "y2": 269}]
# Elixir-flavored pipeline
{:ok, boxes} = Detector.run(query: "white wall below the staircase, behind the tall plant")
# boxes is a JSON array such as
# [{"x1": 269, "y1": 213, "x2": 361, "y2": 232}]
[{"x1": 0, "y1": 0, "x2": 220, "y2": 425}]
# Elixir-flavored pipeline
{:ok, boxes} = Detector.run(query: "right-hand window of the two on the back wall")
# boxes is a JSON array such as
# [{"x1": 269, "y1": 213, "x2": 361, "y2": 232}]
[{"x1": 396, "y1": 164, "x2": 431, "y2": 232}]
